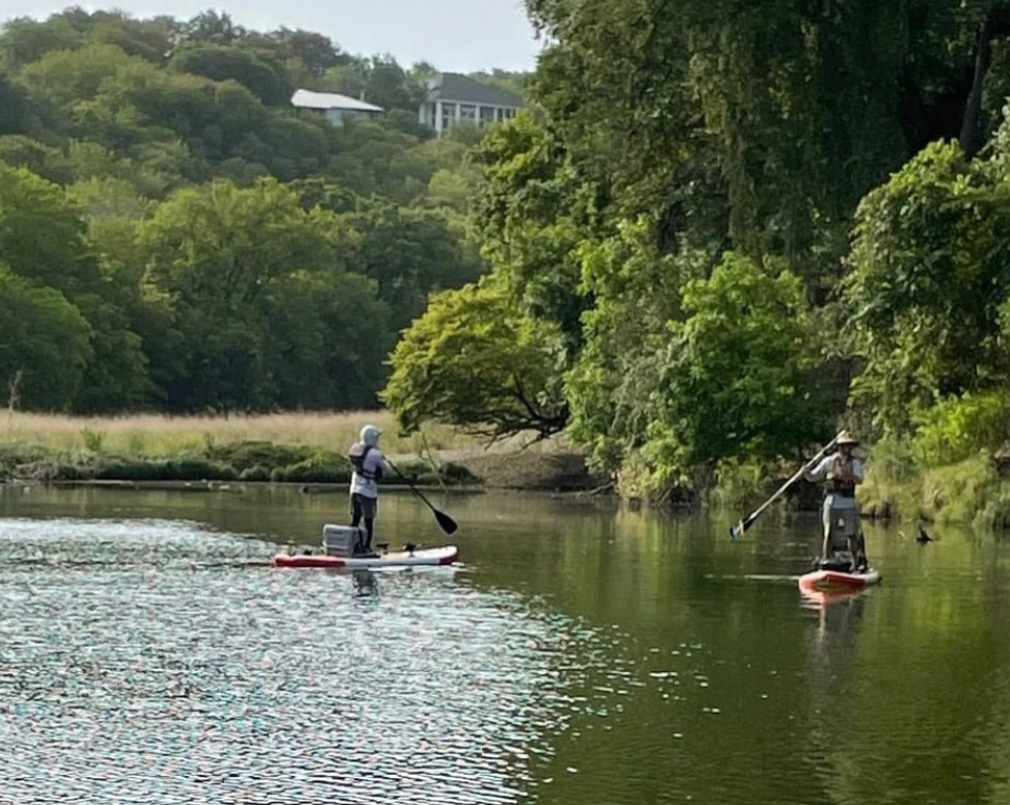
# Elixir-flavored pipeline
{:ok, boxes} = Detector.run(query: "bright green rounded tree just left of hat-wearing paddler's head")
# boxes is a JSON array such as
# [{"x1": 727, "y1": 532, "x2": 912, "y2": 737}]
[{"x1": 647, "y1": 254, "x2": 837, "y2": 477}]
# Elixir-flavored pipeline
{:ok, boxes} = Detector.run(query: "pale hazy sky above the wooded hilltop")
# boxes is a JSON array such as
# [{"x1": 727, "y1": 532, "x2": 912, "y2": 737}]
[{"x1": 0, "y1": 0, "x2": 539, "y2": 73}]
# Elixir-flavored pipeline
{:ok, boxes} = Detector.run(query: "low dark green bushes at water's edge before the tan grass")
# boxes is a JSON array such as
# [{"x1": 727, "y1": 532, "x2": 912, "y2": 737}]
[{"x1": 0, "y1": 440, "x2": 600, "y2": 492}]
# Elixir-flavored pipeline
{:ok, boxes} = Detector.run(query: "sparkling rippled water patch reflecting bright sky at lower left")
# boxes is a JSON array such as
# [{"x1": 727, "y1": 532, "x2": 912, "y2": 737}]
[{"x1": 0, "y1": 520, "x2": 594, "y2": 805}]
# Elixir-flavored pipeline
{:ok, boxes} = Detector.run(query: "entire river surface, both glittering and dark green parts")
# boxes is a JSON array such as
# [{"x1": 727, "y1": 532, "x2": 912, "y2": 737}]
[{"x1": 0, "y1": 482, "x2": 1010, "y2": 805}]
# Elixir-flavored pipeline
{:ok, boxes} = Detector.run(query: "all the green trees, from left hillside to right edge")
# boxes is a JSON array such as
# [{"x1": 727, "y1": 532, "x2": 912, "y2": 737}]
[{"x1": 15, "y1": 0, "x2": 1010, "y2": 498}]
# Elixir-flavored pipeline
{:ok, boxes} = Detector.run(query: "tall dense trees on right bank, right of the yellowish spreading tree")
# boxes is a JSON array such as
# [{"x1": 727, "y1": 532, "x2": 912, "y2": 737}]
[{"x1": 383, "y1": 0, "x2": 1010, "y2": 486}]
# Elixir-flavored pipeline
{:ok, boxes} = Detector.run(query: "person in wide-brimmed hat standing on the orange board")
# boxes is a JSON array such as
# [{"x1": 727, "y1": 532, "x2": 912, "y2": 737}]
[{"x1": 804, "y1": 430, "x2": 867, "y2": 572}]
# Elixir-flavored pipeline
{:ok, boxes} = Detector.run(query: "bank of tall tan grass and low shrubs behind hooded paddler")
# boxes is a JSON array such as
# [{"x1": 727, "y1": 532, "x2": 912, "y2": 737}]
[{"x1": 0, "y1": 411, "x2": 598, "y2": 490}]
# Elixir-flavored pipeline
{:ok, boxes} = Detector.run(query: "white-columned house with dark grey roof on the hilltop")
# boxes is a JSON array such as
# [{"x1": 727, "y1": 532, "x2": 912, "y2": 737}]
[{"x1": 417, "y1": 73, "x2": 522, "y2": 134}]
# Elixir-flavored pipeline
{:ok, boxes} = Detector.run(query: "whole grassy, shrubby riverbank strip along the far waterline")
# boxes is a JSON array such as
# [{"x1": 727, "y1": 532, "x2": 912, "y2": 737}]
[{"x1": 13, "y1": 411, "x2": 1010, "y2": 528}]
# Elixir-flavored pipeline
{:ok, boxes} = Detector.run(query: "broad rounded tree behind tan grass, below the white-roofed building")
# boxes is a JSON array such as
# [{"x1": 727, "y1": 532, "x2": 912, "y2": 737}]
[{"x1": 138, "y1": 179, "x2": 391, "y2": 410}]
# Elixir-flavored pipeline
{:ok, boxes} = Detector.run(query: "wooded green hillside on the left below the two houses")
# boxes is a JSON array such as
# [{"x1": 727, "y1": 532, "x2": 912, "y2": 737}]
[{"x1": 0, "y1": 8, "x2": 509, "y2": 412}]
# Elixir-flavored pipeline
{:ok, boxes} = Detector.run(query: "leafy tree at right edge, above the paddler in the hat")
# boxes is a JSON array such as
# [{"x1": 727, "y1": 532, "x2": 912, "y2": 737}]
[{"x1": 843, "y1": 133, "x2": 1010, "y2": 432}]
